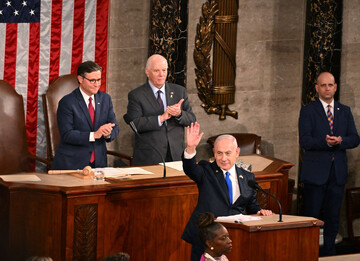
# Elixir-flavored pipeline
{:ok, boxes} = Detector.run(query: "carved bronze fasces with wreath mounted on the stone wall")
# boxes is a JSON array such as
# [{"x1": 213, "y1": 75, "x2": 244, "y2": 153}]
[{"x1": 194, "y1": 0, "x2": 239, "y2": 120}]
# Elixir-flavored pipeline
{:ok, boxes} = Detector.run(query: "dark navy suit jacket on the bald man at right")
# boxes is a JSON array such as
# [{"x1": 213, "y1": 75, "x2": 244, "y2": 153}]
[{"x1": 299, "y1": 99, "x2": 359, "y2": 185}]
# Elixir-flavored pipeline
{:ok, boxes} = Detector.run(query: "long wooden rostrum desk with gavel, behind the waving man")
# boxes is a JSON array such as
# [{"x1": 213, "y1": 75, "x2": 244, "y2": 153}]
[{"x1": 0, "y1": 155, "x2": 292, "y2": 261}]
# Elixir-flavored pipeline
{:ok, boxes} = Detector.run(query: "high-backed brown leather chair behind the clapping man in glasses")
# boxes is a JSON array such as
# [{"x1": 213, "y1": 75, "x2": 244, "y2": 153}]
[{"x1": 42, "y1": 74, "x2": 132, "y2": 165}]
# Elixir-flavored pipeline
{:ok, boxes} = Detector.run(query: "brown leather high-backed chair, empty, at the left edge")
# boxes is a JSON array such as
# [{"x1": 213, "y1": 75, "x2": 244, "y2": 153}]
[{"x1": 0, "y1": 80, "x2": 49, "y2": 174}]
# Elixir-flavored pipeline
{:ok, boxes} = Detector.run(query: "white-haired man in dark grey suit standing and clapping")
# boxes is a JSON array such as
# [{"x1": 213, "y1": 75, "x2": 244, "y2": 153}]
[{"x1": 127, "y1": 54, "x2": 196, "y2": 165}]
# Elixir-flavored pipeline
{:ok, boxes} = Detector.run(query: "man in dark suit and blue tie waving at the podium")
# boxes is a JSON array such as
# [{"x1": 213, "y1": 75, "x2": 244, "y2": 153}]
[{"x1": 182, "y1": 122, "x2": 272, "y2": 261}]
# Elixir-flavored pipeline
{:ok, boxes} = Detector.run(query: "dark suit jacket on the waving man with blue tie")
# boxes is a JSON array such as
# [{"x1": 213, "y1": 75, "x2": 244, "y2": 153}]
[{"x1": 182, "y1": 154, "x2": 261, "y2": 245}]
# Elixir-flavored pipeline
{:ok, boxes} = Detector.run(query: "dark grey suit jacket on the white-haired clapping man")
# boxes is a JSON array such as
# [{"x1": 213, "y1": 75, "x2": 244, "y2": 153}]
[{"x1": 127, "y1": 82, "x2": 196, "y2": 165}]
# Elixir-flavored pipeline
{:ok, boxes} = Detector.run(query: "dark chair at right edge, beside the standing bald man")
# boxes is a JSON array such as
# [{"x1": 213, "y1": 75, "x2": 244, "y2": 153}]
[{"x1": 346, "y1": 187, "x2": 360, "y2": 247}]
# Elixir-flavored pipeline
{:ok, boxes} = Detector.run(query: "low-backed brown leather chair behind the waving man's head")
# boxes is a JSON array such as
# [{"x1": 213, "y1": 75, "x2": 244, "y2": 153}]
[{"x1": 207, "y1": 133, "x2": 261, "y2": 155}]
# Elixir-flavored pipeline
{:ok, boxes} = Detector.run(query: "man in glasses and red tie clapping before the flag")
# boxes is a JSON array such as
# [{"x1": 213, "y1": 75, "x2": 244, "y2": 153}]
[{"x1": 51, "y1": 61, "x2": 119, "y2": 169}]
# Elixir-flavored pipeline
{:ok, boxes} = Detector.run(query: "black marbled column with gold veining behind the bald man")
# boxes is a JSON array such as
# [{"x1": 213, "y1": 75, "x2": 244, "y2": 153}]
[{"x1": 302, "y1": 0, "x2": 342, "y2": 105}]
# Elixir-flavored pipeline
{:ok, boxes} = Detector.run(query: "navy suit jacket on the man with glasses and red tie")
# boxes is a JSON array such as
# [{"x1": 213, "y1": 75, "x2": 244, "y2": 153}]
[{"x1": 51, "y1": 88, "x2": 119, "y2": 169}]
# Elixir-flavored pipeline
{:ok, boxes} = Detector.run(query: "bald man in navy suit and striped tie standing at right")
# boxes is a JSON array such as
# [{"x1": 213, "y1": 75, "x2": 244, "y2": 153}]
[{"x1": 299, "y1": 72, "x2": 359, "y2": 255}]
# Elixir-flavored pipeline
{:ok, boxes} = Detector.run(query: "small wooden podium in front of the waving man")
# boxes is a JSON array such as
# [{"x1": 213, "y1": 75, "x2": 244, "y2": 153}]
[{"x1": 221, "y1": 215, "x2": 324, "y2": 261}]
